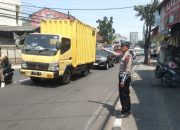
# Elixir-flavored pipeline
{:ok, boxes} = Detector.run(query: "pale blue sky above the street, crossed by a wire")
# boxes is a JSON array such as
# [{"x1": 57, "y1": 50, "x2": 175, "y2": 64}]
[{"x1": 21, "y1": 0, "x2": 151, "y2": 40}]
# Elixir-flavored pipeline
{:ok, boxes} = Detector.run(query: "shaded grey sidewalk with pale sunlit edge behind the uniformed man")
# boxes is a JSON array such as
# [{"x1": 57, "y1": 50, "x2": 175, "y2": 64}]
[{"x1": 113, "y1": 60, "x2": 180, "y2": 130}]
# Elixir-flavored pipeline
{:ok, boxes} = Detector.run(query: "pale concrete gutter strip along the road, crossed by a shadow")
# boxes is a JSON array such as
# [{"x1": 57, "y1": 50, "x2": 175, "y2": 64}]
[{"x1": 85, "y1": 89, "x2": 119, "y2": 130}]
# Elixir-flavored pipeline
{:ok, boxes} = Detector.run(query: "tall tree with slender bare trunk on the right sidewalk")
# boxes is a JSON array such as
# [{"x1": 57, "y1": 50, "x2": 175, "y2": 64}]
[{"x1": 134, "y1": 0, "x2": 159, "y2": 64}]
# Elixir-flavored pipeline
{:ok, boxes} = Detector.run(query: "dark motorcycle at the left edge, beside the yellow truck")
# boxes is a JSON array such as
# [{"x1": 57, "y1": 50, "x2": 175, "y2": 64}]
[{"x1": 2, "y1": 57, "x2": 14, "y2": 84}]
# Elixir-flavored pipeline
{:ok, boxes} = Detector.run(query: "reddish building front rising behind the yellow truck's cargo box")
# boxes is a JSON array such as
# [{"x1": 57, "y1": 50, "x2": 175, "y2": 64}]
[{"x1": 30, "y1": 8, "x2": 75, "y2": 27}]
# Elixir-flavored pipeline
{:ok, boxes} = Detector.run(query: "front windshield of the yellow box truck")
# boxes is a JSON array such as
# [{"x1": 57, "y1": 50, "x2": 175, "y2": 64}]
[{"x1": 23, "y1": 34, "x2": 59, "y2": 55}]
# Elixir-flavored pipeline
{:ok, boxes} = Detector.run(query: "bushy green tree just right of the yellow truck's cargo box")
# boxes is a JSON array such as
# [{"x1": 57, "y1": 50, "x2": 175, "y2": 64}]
[{"x1": 96, "y1": 16, "x2": 116, "y2": 44}]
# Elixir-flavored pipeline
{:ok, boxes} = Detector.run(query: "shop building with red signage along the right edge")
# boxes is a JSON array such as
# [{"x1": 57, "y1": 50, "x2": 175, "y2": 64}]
[{"x1": 153, "y1": 0, "x2": 180, "y2": 68}]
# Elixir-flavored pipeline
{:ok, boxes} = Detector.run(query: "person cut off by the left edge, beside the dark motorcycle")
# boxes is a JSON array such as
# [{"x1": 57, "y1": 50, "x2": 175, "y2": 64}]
[{"x1": 0, "y1": 48, "x2": 5, "y2": 88}]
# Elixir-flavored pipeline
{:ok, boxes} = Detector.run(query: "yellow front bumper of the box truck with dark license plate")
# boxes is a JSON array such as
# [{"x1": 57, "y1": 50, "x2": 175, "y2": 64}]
[{"x1": 20, "y1": 69, "x2": 59, "y2": 79}]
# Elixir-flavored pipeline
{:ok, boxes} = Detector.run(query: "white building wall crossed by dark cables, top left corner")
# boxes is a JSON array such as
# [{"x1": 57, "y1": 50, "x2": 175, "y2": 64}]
[{"x1": 0, "y1": 0, "x2": 22, "y2": 26}]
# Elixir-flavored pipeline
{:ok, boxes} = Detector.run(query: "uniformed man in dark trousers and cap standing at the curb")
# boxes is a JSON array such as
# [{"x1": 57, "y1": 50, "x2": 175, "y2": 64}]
[{"x1": 119, "y1": 43, "x2": 133, "y2": 115}]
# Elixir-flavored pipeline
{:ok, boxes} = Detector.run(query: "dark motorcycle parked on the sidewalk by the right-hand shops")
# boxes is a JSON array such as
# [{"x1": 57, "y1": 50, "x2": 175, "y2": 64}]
[{"x1": 155, "y1": 63, "x2": 180, "y2": 87}]
